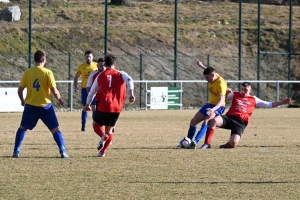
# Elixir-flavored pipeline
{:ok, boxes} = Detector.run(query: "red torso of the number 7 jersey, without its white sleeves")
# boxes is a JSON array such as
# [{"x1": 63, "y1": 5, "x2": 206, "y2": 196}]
[{"x1": 97, "y1": 68, "x2": 126, "y2": 113}]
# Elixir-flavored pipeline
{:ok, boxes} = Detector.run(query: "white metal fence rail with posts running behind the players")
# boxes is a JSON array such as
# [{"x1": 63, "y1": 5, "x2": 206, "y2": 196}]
[{"x1": 0, "y1": 80, "x2": 300, "y2": 111}]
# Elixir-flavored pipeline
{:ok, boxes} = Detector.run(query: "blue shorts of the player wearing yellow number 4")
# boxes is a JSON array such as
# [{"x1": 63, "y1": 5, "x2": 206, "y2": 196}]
[{"x1": 21, "y1": 103, "x2": 59, "y2": 130}]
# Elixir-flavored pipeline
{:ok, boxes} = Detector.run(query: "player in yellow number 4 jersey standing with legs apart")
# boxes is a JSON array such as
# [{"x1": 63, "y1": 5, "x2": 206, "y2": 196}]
[{"x1": 13, "y1": 50, "x2": 69, "y2": 158}]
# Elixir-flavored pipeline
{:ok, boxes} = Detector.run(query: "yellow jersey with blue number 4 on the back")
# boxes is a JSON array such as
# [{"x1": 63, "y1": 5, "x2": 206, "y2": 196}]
[{"x1": 20, "y1": 66, "x2": 56, "y2": 107}]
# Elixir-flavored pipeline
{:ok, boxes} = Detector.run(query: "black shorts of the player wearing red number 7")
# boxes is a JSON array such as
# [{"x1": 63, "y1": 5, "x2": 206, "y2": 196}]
[{"x1": 93, "y1": 110, "x2": 120, "y2": 126}]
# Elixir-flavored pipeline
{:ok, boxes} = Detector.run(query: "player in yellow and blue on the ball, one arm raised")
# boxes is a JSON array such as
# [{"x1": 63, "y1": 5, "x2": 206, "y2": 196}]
[{"x1": 177, "y1": 60, "x2": 227, "y2": 149}]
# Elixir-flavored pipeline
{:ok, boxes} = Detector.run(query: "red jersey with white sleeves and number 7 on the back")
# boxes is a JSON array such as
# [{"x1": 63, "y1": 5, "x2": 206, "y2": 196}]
[{"x1": 87, "y1": 68, "x2": 134, "y2": 113}]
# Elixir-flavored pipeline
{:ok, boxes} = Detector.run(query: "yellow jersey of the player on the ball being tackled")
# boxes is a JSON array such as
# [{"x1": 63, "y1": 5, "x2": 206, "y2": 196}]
[{"x1": 207, "y1": 74, "x2": 227, "y2": 106}]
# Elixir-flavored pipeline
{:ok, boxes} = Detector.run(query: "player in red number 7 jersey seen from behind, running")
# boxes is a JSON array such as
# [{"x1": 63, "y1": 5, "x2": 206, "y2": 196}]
[{"x1": 85, "y1": 54, "x2": 135, "y2": 158}]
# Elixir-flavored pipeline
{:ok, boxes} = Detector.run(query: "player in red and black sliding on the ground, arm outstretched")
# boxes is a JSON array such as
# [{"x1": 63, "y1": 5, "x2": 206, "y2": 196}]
[{"x1": 206, "y1": 82, "x2": 291, "y2": 148}]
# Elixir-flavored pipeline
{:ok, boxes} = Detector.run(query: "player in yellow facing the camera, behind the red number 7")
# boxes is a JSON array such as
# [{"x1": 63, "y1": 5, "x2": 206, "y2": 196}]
[{"x1": 74, "y1": 51, "x2": 97, "y2": 131}]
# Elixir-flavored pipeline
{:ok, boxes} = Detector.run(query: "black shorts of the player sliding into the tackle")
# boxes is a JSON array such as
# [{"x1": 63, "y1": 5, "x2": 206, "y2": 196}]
[{"x1": 220, "y1": 115, "x2": 247, "y2": 136}]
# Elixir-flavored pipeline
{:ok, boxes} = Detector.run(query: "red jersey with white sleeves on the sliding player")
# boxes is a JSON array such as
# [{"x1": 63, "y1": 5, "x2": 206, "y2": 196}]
[{"x1": 226, "y1": 92, "x2": 272, "y2": 124}]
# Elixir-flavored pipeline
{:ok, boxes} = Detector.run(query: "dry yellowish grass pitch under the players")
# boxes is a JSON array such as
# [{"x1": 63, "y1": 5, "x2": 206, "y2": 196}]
[{"x1": 0, "y1": 108, "x2": 300, "y2": 199}]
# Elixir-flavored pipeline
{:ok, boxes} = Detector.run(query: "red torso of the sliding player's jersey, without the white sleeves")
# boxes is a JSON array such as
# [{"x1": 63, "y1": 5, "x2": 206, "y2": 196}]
[{"x1": 226, "y1": 92, "x2": 256, "y2": 125}]
